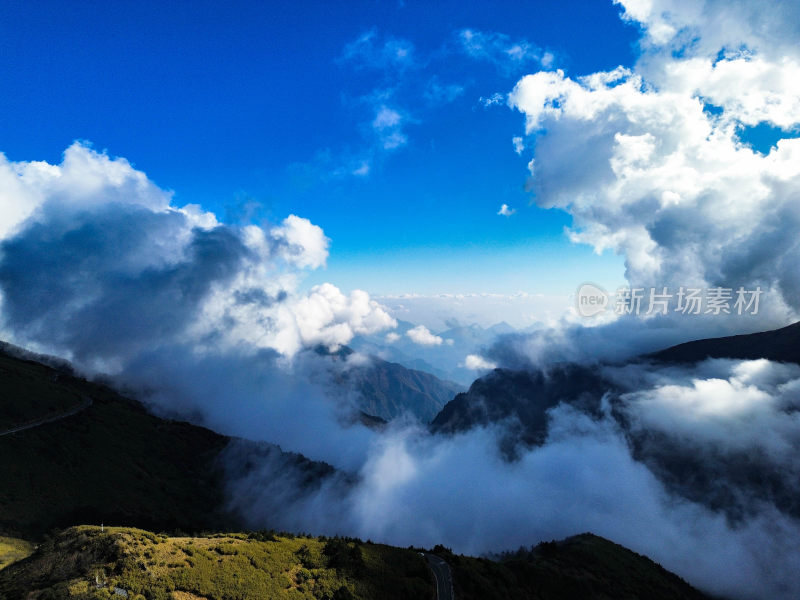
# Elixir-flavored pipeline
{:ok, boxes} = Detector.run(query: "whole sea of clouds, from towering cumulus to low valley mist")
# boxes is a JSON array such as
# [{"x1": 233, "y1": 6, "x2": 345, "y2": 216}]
[{"x1": 0, "y1": 0, "x2": 800, "y2": 598}]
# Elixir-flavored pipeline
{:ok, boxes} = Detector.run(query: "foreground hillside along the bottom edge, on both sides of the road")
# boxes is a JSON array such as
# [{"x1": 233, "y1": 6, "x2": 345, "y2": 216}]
[{"x1": 0, "y1": 527, "x2": 708, "y2": 600}]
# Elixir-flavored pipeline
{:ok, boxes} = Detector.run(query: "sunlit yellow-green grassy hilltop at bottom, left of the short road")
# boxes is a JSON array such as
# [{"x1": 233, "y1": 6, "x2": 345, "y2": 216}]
[{"x1": 0, "y1": 527, "x2": 434, "y2": 600}]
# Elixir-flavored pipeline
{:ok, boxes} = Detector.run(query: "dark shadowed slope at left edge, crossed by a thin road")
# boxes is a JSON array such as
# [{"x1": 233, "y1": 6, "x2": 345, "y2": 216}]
[{"x1": 0, "y1": 346, "x2": 228, "y2": 539}]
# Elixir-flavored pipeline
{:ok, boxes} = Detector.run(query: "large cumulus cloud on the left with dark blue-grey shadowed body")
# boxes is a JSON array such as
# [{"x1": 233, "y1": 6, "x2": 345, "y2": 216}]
[{"x1": 0, "y1": 143, "x2": 396, "y2": 369}]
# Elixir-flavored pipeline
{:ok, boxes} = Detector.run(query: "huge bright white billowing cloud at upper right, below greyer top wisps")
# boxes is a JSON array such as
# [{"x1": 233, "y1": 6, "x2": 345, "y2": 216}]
[{"x1": 509, "y1": 19, "x2": 800, "y2": 309}]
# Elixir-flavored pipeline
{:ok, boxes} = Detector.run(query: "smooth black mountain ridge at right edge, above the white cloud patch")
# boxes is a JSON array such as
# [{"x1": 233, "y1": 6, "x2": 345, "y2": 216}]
[{"x1": 645, "y1": 322, "x2": 800, "y2": 364}]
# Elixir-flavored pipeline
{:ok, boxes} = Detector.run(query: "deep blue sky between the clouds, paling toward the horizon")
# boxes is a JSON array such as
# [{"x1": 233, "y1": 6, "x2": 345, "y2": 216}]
[{"x1": 0, "y1": 1, "x2": 638, "y2": 294}]
